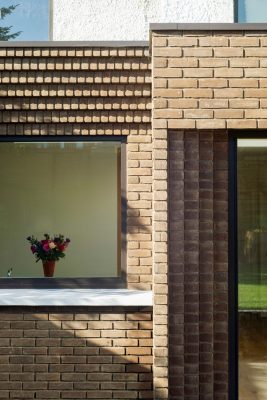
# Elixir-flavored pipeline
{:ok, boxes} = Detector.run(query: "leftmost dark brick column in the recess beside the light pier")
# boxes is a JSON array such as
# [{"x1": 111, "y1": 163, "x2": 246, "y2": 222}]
[{"x1": 168, "y1": 131, "x2": 185, "y2": 400}]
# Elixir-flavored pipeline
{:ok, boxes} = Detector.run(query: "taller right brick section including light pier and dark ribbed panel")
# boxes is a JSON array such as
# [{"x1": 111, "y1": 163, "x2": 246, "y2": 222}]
[{"x1": 151, "y1": 25, "x2": 267, "y2": 400}]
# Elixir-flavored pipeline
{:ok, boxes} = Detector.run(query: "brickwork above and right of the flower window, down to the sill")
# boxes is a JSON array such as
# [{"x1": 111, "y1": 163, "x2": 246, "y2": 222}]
[{"x1": 0, "y1": 47, "x2": 152, "y2": 290}]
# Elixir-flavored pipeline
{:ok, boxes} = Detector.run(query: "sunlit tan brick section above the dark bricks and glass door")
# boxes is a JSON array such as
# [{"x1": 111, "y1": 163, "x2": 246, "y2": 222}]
[{"x1": 152, "y1": 28, "x2": 267, "y2": 129}]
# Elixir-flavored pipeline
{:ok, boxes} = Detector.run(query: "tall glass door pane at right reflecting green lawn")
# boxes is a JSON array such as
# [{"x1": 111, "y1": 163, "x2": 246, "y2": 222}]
[{"x1": 240, "y1": 139, "x2": 267, "y2": 400}]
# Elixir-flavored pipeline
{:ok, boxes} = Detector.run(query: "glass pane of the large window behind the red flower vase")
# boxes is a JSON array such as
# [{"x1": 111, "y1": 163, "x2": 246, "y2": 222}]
[{"x1": 0, "y1": 142, "x2": 120, "y2": 277}]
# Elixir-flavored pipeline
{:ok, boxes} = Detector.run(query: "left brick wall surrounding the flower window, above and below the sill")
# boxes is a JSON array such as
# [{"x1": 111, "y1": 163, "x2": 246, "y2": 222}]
[{"x1": 0, "y1": 47, "x2": 153, "y2": 400}]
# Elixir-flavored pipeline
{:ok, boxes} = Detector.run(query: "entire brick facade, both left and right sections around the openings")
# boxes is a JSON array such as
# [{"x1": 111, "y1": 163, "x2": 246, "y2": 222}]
[{"x1": 0, "y1": 28, "x2": 267, "y2": 400}]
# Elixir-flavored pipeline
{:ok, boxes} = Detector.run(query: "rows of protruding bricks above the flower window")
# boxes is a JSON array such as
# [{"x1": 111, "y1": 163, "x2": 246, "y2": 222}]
[{"x1": 0, "y1": 47, "x2": 151, "y2": 135}]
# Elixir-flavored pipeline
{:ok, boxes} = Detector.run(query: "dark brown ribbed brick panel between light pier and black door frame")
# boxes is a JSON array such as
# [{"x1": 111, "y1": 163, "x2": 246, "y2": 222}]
[{"x1": 168, "y1": 131, "x2": 228, "y2": 400}]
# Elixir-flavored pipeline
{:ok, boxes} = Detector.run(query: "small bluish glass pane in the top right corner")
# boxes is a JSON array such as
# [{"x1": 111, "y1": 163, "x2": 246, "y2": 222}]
[{"x1": 238, "y1": 0, "x2": 267, "y2": 22}]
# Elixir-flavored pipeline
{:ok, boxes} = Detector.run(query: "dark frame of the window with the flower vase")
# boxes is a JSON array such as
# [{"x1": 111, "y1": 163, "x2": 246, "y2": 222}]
[{"x1": 0, "y1": 135, "x2": 127, "y2": 289}]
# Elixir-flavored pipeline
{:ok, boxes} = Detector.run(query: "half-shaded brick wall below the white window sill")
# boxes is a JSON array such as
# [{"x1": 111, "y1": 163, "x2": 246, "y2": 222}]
[{"x1": 0, "y1": 307, "x2": 153, "y2": 400}]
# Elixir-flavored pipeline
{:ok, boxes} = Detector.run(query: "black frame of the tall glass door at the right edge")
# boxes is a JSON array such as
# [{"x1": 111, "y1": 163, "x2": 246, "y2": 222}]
[{"x1": 228, "y1": 130, "x2": 267, "y2": 400}]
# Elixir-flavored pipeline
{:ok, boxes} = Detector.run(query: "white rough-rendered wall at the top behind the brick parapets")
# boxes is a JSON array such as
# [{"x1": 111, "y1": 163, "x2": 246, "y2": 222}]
[{"x1": 53, "y1": 0, "x2": 234, "y2": 40}]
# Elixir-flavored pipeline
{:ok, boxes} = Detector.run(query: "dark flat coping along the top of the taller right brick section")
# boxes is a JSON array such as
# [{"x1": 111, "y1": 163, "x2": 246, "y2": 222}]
[{"x1": 149, "y1": 22, "x2": 267, "y2": 31}]
